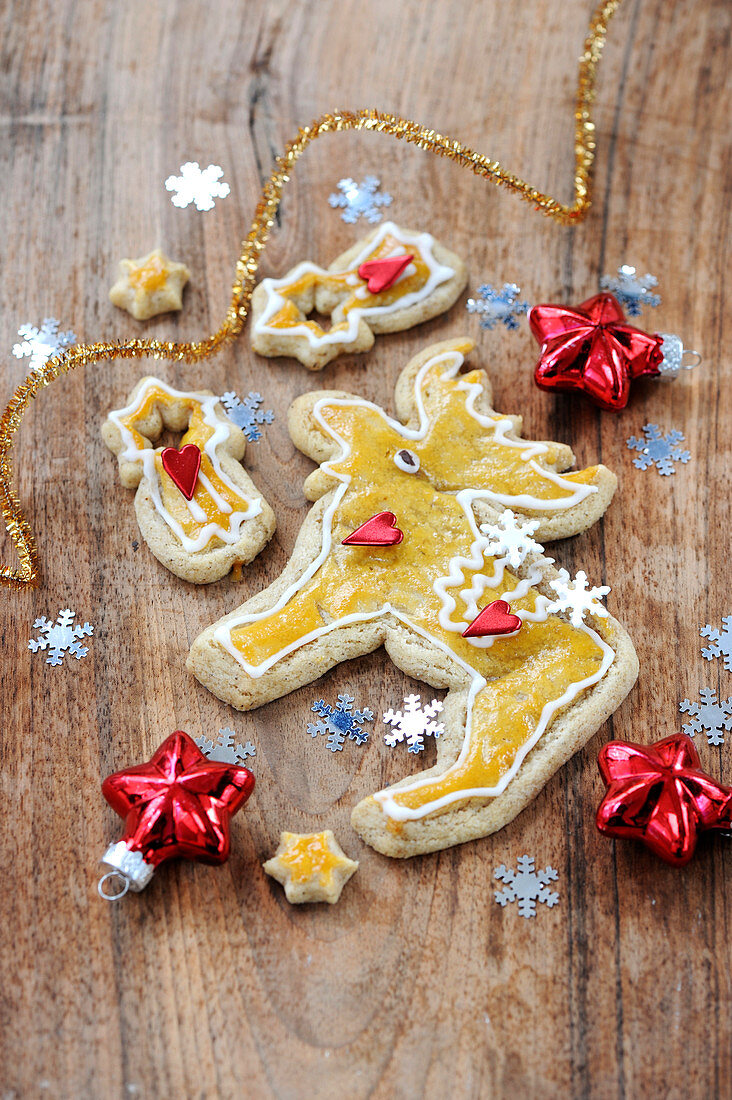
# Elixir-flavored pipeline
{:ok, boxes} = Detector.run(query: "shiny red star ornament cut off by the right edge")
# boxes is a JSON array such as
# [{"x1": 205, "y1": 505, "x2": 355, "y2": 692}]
[{"x1": 597, "y1": 734, "x2": 732, "y2": 867}]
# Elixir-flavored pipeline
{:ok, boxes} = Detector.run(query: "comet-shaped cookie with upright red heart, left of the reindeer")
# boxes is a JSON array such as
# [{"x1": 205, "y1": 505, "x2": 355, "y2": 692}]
[{"x1": 101, "y1": 377, "x2": 275, "y2": 584}]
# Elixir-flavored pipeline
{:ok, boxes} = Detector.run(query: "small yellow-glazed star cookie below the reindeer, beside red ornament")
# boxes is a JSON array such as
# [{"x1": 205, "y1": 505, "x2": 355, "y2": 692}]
[{"x1": 263, "y1": 828, "x2": 359, "y2": 905}]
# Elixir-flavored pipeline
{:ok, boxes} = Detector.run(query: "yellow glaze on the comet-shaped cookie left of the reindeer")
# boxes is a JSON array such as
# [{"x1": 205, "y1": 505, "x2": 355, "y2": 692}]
[{"x1": 121, "y1": 386, "x2": 250, "y2": 548}]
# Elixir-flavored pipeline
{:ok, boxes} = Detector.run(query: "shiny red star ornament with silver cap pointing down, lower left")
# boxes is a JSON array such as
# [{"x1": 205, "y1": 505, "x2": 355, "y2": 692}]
[{"x1": 100, "y1": 729, "x2": 254, "y2": 900}]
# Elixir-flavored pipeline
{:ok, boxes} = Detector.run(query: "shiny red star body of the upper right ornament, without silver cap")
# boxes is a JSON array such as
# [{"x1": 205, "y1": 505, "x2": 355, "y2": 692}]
[{"x1": 528, "y1": 294, "x2": 664, "y2": 413}]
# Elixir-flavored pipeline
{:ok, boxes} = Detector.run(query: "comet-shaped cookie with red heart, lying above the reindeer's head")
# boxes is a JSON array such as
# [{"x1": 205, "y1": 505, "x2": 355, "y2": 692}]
[{"x1": 251, "y1": 221, "x2": 468, "y2": 371}]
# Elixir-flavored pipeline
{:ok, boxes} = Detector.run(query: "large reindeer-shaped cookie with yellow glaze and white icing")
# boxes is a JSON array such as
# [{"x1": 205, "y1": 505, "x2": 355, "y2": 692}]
[{"x1": 188, "y1": 340, "x2": 637, "y2": 856}]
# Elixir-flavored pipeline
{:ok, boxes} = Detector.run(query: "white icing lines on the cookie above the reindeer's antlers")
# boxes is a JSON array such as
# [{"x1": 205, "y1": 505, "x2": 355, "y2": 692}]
[{"x1": 253, "y1": 221, "x2": 455, "y2": 348}]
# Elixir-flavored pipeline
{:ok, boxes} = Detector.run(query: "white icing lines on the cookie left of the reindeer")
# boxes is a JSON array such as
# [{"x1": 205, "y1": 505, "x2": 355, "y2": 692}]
[{"x1": 109, "y1": 377, "x2": 262, "y2": 553}]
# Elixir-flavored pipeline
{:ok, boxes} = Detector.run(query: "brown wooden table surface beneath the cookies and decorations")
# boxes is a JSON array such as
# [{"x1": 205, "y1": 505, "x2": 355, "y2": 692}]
[{"x1": 0, "y1": 0, "x2": 732, "y2": 1100}]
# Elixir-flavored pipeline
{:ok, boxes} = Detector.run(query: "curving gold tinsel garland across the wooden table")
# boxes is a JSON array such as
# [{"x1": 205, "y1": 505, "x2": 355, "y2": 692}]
[{"x1": 0, "y1": 0, "x2": 621, "y2": 589}]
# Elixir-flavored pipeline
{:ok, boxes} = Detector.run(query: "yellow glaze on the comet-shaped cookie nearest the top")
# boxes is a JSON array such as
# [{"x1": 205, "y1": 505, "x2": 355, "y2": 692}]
[{"x1": 266, "y1": 233, "x2": 429, "y2": 337}]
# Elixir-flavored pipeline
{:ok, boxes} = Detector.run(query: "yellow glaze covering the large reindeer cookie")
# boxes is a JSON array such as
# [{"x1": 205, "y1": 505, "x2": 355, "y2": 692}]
[{"x1": 230, "y1": 356, "x2": 603, "y2": 807}]
